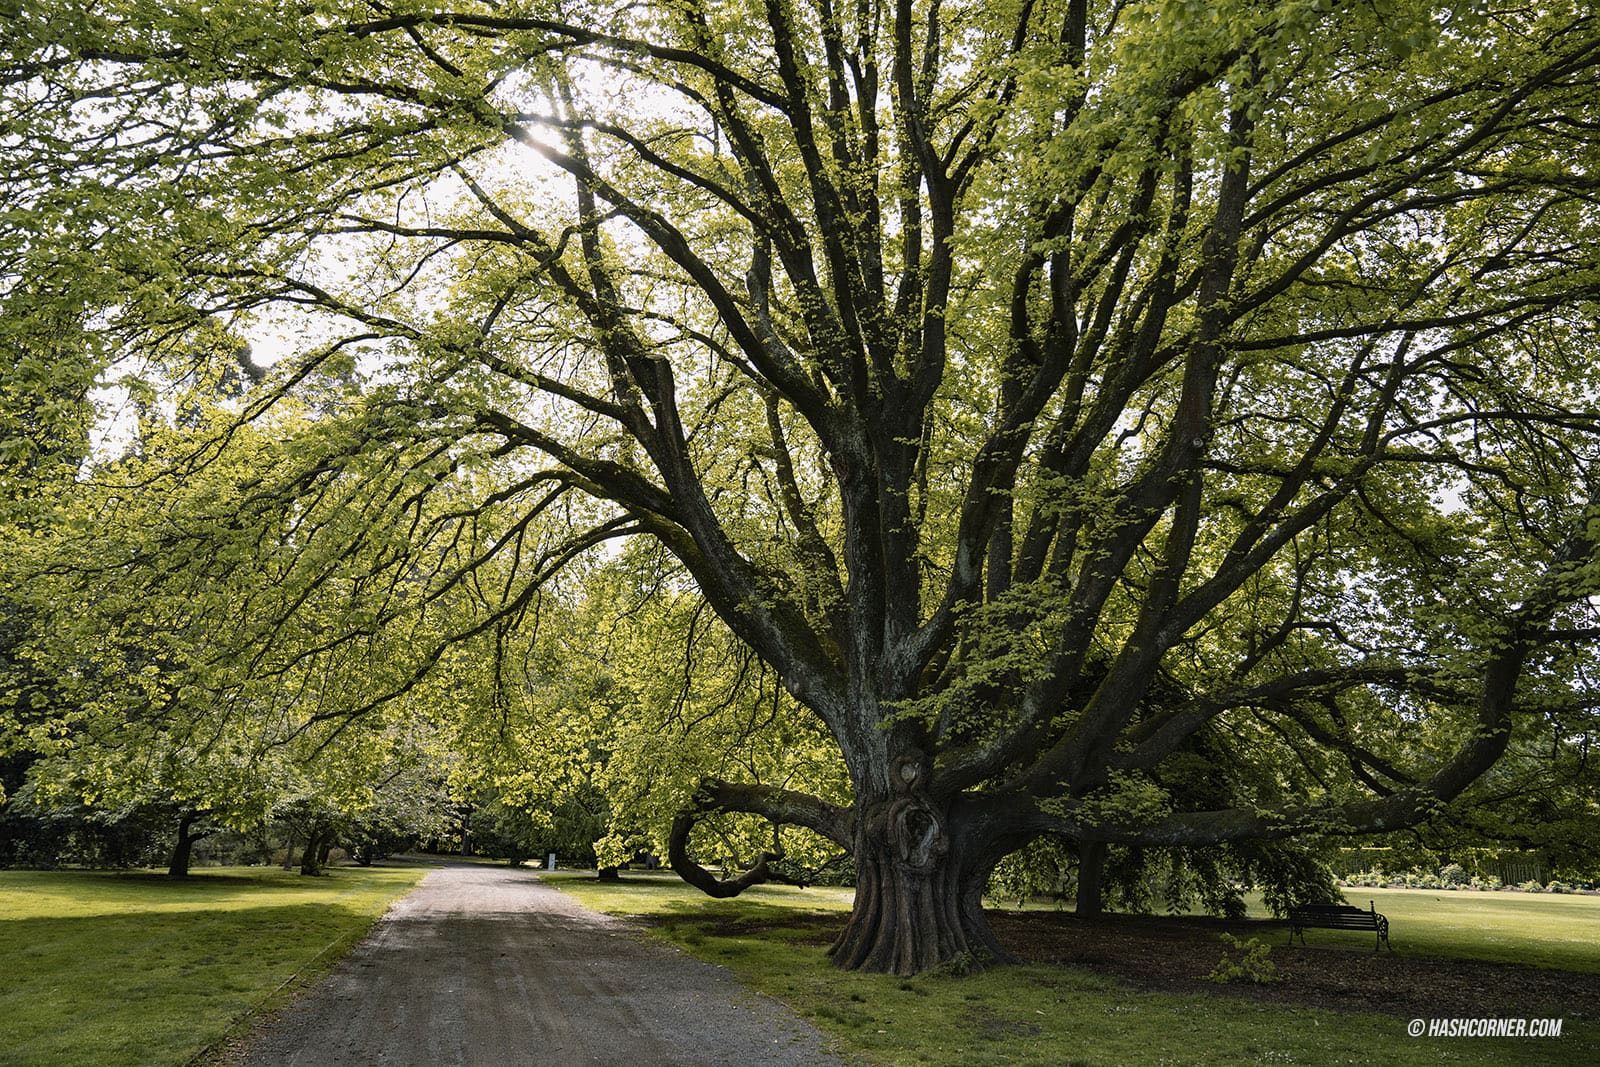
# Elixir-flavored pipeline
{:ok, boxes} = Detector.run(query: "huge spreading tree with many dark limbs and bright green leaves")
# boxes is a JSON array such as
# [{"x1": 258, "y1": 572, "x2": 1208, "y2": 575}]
[{"x1": 0, "y1": 0, "x2": 1600, "y2": 973}]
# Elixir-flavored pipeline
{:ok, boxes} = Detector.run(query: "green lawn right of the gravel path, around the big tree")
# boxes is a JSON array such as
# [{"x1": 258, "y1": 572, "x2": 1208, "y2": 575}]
[{"x1": 542, "y1": 873, "x2": 1600, "y2": 1067}]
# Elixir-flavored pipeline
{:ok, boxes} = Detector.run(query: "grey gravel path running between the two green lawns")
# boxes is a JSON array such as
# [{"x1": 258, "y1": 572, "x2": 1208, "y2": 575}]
[{"x1": 242, "y1": 865, "x2": 845, "y2": 1067}]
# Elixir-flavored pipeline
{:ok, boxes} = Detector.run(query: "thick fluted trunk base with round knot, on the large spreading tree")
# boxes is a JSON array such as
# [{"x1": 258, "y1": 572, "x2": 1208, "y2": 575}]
[{"x1": 830, "y1": 793, "x2": 1010, "y2": 974}]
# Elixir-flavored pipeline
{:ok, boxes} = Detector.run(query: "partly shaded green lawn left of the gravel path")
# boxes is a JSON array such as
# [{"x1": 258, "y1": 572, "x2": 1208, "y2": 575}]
[{"x1": 0, "y1": 867, "x2": 427, "y2": 1067}]
